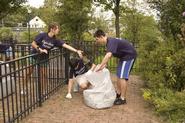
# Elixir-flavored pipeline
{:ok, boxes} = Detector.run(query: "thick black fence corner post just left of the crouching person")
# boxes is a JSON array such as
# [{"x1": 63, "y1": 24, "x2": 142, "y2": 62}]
[{"x1": 64, "y1": 50, "x2": 70, "y2": 84}]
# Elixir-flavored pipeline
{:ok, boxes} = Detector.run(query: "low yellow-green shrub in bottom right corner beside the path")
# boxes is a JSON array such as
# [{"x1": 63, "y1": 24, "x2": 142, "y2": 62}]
[{"x1": 143, "y1": 86, "x2": 185, "y2": 123}]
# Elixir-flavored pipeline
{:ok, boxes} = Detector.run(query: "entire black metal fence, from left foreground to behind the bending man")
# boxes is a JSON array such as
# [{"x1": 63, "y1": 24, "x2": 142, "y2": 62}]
[{"x1": 0, "y1": 41, "x2": 137, "y2": 123}]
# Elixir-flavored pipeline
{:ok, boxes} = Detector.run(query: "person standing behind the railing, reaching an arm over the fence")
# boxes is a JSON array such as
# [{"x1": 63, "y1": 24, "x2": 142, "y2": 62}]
[{"x1": 21, "y1": 23, "x2": 82, "y2": 97}]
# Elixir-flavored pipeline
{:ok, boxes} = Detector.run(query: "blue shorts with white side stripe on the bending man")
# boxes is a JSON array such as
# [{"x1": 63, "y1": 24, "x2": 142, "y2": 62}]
[{"x1": 117, "y1": 59, "x2": 135, "y2": 80}]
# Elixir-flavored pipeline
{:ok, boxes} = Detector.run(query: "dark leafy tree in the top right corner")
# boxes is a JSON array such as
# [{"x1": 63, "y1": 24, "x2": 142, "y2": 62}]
[{"x1": 148, "y1": 0, "x2": 185, "y2": 40}]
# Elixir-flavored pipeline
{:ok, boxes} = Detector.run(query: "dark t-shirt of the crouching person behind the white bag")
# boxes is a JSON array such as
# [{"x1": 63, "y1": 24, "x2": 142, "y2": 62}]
[{"x1": 69, "y1": 59, "x2": 92, "y2": 78}]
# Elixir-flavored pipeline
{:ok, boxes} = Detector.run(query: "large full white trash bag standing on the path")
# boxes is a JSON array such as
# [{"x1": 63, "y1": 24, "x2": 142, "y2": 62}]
[{"x1": 83, "y1": 68, "x2": 116, "y2": 109}]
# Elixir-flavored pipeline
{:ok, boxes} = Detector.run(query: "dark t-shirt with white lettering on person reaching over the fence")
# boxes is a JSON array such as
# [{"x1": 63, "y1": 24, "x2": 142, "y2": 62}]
[{"x1": 32, "y1": 33, "x2": 64, "y2": 59}]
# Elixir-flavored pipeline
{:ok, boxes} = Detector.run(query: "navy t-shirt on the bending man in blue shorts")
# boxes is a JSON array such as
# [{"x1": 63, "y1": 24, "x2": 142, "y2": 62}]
[{"x1": 106, "y1": 38, "x2": 137, "y2": 61}]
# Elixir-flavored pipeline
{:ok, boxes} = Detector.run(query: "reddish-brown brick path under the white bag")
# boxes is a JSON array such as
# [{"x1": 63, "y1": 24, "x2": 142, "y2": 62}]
[{"x1": 22, "y1": 76, "x2": 162, "y2": 123}]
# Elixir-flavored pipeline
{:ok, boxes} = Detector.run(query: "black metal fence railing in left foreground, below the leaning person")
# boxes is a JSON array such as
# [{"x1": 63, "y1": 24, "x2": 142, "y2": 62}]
[{"x1": 0, "y1": 49, "x2": 69, "y2": 123}]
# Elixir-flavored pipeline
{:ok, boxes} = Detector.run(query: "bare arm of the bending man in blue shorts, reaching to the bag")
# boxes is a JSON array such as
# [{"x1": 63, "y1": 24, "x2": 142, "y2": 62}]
[{"x1": 96, "y1": 52, "x2": 112, "y2": 72}]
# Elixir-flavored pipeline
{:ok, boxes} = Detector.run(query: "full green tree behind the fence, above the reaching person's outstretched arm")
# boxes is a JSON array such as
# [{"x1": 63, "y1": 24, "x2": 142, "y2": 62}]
[{"x1": 57, "y1": 0, "x2": 92, "y2": 40}]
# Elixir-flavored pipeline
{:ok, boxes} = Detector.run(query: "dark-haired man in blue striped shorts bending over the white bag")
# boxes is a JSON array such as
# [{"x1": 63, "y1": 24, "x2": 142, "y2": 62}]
[{"x1": 94, "y1": 30, "x2": 137, "y2": 105}]
